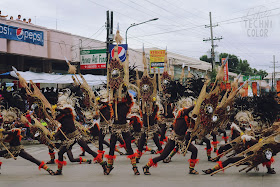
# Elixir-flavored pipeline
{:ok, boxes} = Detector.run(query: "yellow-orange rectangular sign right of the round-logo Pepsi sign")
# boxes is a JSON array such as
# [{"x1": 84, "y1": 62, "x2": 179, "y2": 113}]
[{"x1": 150, "y1": 50, "x2": 165, "y2": 72}]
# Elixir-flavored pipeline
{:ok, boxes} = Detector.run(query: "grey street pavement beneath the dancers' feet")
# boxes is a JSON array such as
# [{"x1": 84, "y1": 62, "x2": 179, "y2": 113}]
[{"x1": 0, "y1": 136, "x2": 280, "y2": 187}]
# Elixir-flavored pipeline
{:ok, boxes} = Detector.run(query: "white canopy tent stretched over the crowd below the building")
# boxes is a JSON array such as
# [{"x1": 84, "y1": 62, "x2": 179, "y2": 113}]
[{"x1": 0, "y1": 71, "x2": 107, "y2": 86}]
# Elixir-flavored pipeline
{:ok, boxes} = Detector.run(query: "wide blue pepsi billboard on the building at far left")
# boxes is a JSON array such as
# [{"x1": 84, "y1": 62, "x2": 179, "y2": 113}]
[{"x1": 0, "y1": 24, "x2": 44, "y2": 46}]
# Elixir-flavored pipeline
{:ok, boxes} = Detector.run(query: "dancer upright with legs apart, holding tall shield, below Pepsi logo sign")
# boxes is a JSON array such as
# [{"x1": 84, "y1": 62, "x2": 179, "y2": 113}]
[{"x1": 106, "y1": 26, "x2": 140, "y2": 175}]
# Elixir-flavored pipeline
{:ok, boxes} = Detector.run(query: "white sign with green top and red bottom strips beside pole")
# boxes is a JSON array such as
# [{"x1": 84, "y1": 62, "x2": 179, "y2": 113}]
[{"x1": 80, "y1": 49, "x2": 107, "y2": 69}]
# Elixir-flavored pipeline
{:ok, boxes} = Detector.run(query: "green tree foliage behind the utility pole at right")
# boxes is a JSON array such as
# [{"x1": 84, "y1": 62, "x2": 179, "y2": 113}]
[{"x1": 200, "y1": 53, "x2": 268, "y2": 78}]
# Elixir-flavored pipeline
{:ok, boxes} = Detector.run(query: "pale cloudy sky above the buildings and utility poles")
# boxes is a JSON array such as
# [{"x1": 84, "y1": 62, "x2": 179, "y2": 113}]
[{"x1": 0, "y1": 0, "x2": 280, "y2": 72}]
